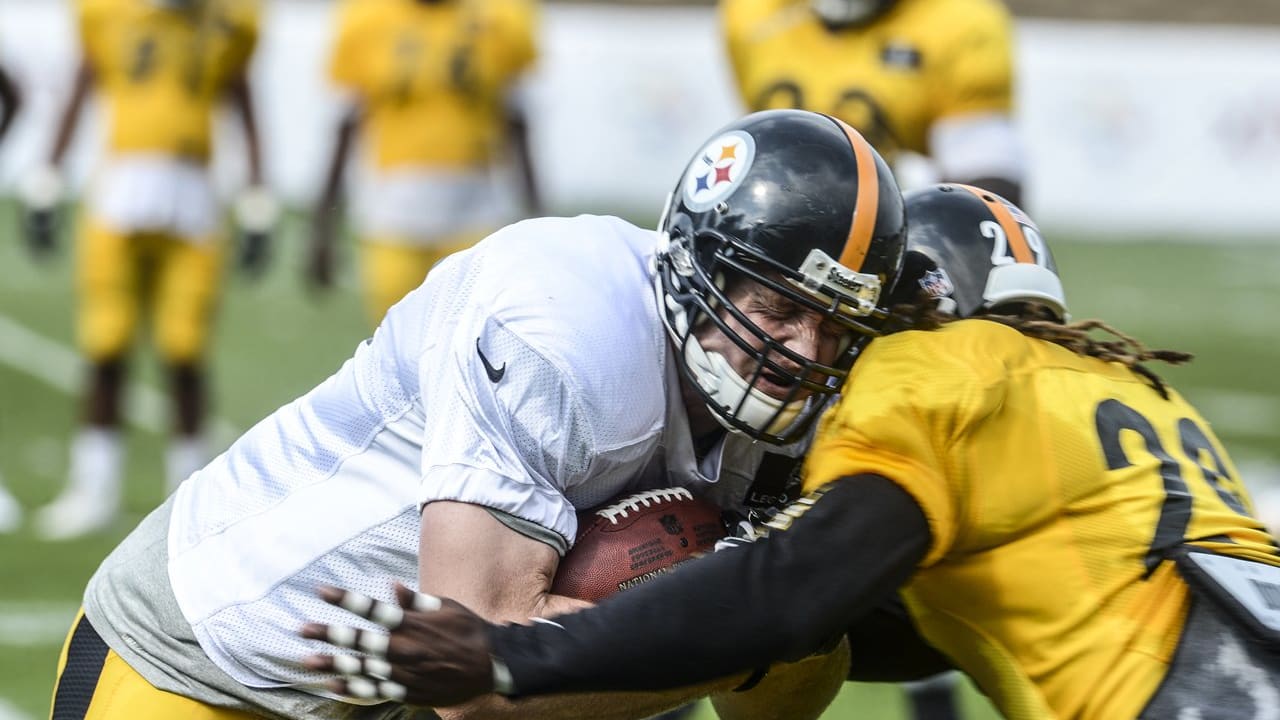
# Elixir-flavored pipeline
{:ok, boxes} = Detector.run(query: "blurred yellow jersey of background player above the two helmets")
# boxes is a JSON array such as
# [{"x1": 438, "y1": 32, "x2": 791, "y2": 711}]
[{"x1": 721, "y1": 0, "x2": 1012, "y2": 161}]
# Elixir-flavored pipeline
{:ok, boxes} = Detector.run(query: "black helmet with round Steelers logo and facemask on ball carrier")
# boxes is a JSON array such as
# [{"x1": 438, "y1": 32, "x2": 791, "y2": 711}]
[{"x1": 655, "y1": 110, "x2": 906, "y2": 445}]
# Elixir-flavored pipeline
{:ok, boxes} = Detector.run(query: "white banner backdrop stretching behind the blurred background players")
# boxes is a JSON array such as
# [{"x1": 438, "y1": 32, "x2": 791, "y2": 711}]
[{"x1": 0, "y1": 0, "x2": 1280, "y2": 236}]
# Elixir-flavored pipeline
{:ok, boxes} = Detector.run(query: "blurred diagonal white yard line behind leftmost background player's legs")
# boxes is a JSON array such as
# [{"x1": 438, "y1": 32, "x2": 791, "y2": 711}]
[{"x1": 0, "y1": 315, "x2": 239, "y2": 438}]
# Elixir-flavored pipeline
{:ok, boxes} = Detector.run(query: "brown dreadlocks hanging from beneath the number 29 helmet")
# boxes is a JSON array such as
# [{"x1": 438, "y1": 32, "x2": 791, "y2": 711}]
[{"x1": 886, "y1": 295, "x2": 1193, "y2": 400}]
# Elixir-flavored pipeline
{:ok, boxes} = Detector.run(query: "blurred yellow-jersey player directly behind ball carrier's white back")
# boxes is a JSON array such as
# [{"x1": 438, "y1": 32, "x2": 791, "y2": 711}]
[{"x1": 310, "y1": 0, "x2": 540, "y2": 324}]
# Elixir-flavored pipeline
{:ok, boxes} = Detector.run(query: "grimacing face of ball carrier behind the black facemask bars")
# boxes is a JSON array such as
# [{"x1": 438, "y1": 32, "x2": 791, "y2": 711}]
[{"x1": 694, "y1": 281, "x2": 851, "y2": 400}]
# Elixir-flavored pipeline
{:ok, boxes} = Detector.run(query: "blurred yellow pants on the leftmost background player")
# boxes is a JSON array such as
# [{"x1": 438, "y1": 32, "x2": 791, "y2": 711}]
[{"x1": 77, "y1": 219, "x2": 223, "y2": 363}]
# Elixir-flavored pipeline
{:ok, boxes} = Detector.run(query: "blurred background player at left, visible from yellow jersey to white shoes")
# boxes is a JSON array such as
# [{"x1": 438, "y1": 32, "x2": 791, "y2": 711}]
[{"x1": 23, "y1": 0, "x2": 274, "y2": 539}]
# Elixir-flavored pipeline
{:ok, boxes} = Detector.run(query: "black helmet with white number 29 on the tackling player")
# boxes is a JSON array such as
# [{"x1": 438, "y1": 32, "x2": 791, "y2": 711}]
[{"x1": 890, "y1": 184, "x2": 1070, "y2": 322}]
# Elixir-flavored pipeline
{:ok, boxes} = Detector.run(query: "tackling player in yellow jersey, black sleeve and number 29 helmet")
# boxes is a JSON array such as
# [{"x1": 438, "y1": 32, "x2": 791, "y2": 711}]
[{"x1": 296, "y1": 186, "x2": 1280, "y2": 720}]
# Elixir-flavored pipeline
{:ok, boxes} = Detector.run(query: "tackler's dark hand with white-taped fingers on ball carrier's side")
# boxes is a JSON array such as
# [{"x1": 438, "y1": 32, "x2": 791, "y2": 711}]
[{"x1": 302, "y1": 583, "x2": 499, "y2": 707}]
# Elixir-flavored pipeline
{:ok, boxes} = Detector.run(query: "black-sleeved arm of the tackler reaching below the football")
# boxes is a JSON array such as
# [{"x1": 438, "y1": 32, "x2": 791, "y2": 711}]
[{"x1": 489, "y1": 475, "x2": 929, "y2": 696}]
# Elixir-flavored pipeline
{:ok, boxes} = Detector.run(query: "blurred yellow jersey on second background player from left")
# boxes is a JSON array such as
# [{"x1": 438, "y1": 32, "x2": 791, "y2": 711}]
[{"x1": 330, "y1": 0, "x2": 536, "y2": 169}]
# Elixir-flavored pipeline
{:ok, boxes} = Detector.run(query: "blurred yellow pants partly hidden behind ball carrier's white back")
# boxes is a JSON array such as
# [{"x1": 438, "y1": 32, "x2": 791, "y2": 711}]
[{"x1": 360, "y1": 232, "x2": 488, "y2": 325}]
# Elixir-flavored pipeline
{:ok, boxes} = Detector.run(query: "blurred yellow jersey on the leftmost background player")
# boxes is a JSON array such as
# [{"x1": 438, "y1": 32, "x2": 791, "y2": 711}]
[{"x1": 79, "y1": 0, "x2": 259, "y2": 161}]
